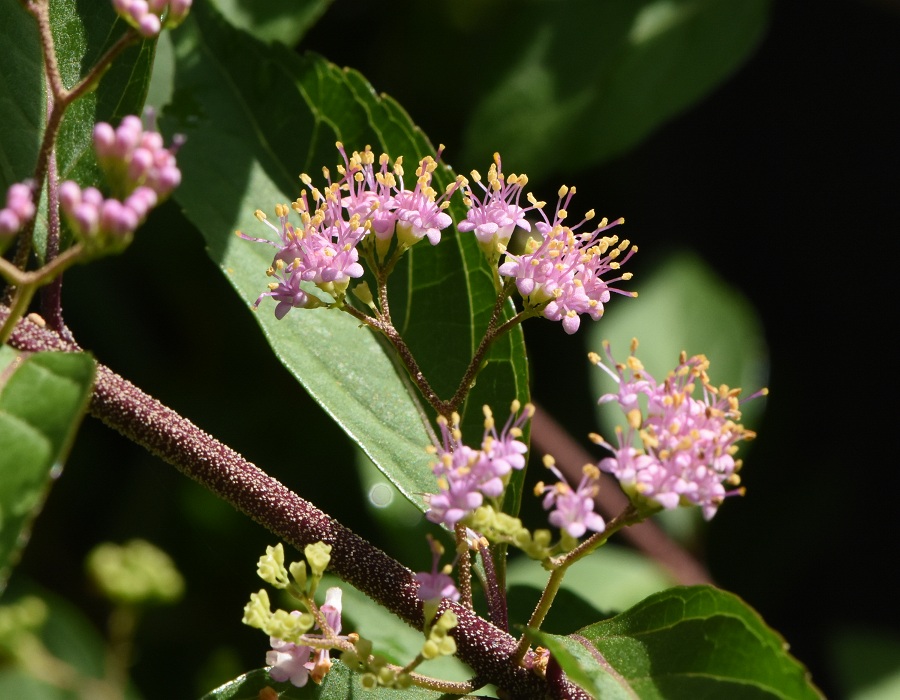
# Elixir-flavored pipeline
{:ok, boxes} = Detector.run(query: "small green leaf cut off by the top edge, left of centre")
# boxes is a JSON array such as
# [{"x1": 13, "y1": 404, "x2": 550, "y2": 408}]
[{"x1": 214, "y1": 0, "x2": 333, "y2": 46}]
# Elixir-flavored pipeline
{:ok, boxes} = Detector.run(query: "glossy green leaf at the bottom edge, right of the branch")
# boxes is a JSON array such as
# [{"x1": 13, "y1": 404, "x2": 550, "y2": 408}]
[{"x1": 530, "y1": 586, "x2": 821, "y2": 700}]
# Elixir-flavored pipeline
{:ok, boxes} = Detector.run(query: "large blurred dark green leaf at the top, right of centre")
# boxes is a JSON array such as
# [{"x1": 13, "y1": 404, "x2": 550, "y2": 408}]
[{"x1": 464, "y1": 0, "x2": 769, "y2": 177}]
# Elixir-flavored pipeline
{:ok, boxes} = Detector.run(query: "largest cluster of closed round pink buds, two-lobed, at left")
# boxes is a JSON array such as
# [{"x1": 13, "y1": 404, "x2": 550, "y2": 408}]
[{"x1": 59, "y1": 116, "x2": 181, "y2": 249}]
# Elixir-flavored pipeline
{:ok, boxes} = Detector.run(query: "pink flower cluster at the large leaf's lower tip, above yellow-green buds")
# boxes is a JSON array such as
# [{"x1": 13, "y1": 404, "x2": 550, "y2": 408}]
[{"x1": 425, "y1": 402, "x2": 534, "y2": 528}]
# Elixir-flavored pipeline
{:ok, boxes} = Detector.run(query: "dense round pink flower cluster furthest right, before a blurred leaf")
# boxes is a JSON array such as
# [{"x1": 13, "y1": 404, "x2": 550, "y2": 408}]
[{"x1": 591, "y1": 343, "x2": 766, "y2": 520}]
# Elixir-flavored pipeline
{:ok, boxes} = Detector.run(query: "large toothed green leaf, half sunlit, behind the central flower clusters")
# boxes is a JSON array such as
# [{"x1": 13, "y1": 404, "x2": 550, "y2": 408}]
[{"x1": 167, "y1": 4, "x2": 528, "y2": 508}]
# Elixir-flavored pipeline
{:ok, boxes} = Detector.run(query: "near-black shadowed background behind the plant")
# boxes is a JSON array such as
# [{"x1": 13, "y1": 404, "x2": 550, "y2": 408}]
[{"x1": 14, "y1": 0, "x2": 900, "y2": 697}]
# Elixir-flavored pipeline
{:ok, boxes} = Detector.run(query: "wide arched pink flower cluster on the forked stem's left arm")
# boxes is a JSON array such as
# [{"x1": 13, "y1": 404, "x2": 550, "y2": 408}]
[{"x1": 237, "y1": 143, "x2": 459, "y2": 319}]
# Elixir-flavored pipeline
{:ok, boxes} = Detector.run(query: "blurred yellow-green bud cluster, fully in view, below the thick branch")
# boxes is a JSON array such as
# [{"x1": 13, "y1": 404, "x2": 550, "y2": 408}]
[{"x1": 87, "y1": 540, "x2": 184, "y2": 605}]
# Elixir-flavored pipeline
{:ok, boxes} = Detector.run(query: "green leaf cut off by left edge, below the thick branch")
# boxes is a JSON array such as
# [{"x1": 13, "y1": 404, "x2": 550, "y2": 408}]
[{"x1": 0, "y1": 346, "x2": 94, "y2": 591}]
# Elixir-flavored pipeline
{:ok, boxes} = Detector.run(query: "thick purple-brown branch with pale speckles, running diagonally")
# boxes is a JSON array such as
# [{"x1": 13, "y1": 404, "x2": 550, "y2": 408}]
[{"x1": 0, "y1": 307, "x2": 588, "y2": 700}]
